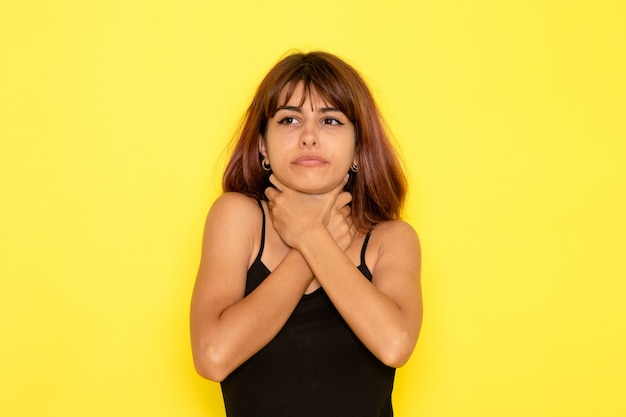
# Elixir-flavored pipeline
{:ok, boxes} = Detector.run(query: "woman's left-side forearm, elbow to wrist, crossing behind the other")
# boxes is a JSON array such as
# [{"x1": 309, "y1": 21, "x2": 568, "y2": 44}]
[{"x1": 191, "y1": 250, "x2": 313, "y2": 381}]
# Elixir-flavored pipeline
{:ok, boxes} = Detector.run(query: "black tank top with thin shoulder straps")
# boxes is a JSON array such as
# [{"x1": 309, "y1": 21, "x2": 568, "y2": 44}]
[{"x1": 221, "y1": 203, "x2": 395, "y2": 417}]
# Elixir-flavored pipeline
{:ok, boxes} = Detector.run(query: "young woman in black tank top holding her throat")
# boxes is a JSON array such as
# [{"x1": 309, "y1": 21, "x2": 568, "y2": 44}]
[{"x1": 191, "y1": 52, "x2": 422, "y2": 417}]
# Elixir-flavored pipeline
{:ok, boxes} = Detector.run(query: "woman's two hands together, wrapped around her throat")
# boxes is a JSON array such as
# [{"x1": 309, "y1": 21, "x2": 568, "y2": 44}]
[{"x1": 265, "y1": 175, "x2": 353, "y2": 248}]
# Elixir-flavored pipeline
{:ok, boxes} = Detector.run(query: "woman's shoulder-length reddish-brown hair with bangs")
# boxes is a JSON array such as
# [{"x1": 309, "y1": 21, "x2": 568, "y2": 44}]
[{"x1": 222, "y1": 52, "x2": 406, "y2": 231}]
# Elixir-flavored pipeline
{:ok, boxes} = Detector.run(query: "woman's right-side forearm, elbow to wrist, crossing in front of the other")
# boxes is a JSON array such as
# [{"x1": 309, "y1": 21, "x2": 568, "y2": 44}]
[{"x1": 298, "y1": 229, "x2": 415, "y2": 367}]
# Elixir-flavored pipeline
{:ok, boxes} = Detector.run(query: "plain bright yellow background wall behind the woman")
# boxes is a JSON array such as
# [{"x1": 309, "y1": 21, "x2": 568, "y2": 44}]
[{"x1": 0, "y1": 0, "x2": 626, "y2": 417}]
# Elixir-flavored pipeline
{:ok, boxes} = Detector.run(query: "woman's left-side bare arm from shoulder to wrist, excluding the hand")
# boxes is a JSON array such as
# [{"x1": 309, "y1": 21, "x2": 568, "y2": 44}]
[{"x1": 190, "y1": 193, "x2": 313, "y2": 381}]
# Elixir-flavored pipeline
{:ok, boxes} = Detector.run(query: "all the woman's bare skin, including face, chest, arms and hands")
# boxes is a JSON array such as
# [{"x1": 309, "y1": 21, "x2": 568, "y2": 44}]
[{"x1": 191, "y1": 86, "x2": 422, "y2": 381}]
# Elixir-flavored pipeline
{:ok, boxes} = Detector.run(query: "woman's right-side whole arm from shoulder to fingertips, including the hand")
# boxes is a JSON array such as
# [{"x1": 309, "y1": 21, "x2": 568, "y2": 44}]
[{"x1": 266, "y1": 178, "x2": 422, "y2": 367}]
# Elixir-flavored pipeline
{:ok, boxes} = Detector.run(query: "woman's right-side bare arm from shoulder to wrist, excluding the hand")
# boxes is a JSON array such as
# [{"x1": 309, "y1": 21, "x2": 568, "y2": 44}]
[{"x1": 295, "y1": 221, "x2": 422, "y2": 367}]
